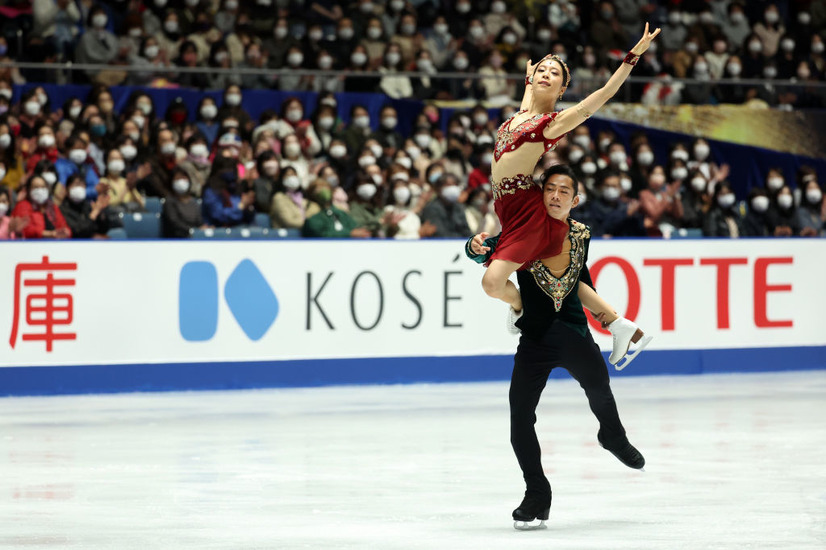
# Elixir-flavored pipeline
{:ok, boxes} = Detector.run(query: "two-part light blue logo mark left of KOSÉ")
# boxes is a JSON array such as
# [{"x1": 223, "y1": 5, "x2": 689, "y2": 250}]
[{"x1": 178, "y1": 260, "x2": 278, "y2": 342}]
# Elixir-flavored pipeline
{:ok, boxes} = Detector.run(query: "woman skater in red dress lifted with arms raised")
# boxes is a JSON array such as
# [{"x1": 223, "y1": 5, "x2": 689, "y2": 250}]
[{"x1": 482, "y1": 23, "x2": 660, "y2": 369}]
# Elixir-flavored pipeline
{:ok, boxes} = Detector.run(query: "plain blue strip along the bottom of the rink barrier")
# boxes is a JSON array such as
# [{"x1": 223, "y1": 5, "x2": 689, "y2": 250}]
[{"x1": 0, "y1": 346, "x2": 826, "y2": 396}]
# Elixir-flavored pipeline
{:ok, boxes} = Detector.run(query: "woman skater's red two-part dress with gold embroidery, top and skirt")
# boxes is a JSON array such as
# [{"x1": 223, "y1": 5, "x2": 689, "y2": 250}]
[{"x1": 490, "y1": 111, "x2": 568, "y2": 270}]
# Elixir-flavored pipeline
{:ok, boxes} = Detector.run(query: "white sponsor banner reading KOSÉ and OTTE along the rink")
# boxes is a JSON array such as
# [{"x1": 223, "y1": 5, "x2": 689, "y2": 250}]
[{"x1": 0, "y1": 239, "x2": 826, "y2": 374}]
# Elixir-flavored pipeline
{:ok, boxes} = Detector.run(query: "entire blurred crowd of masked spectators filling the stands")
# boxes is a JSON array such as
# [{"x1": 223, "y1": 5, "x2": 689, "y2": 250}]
[{"x1": 0, "y1": 0, "x2": 826, "y2": 242}]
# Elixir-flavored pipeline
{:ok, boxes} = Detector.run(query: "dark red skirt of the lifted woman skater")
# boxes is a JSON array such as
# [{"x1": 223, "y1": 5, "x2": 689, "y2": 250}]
[{"x1": 486, "y1": 180, "x2": 568, "y2": 270}]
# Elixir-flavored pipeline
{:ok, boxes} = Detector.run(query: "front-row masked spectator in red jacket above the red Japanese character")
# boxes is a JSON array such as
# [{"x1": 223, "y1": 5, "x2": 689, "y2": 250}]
[{"x1": 11, "y1": 174, "x2": 72, "y2": 239}]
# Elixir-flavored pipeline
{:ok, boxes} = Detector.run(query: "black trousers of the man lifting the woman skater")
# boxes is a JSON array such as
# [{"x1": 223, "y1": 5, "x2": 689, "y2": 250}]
[{"x1": 510, "y1": 321, "x2": 627, "y2": 497}]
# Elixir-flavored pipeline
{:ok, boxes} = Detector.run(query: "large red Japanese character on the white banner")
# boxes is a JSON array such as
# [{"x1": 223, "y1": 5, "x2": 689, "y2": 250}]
[{"x1": 9, "y1": 256, "x2": 77, "y2": 352}]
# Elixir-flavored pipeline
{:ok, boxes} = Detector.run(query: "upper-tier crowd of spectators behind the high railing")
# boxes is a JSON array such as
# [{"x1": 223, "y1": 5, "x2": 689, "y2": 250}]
[{"x1": 0, "y1": 0, "x2": 826, "y2": 108}]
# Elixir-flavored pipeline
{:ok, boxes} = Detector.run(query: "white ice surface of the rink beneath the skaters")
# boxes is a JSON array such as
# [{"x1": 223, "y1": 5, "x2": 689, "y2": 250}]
[{"x1": 0, "y1": 367, "x2": 826, "y2": 550}]
